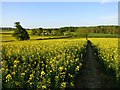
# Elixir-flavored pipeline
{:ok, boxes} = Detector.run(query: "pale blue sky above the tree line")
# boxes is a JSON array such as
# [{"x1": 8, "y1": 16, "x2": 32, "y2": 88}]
[{"x1": 2, "y1": 2, "x2": 118, "y2": 28}]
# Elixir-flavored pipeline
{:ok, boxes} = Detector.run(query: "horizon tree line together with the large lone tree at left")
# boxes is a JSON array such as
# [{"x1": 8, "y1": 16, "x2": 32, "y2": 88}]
[{"x1": 2, "y1": 22, "x2": 120, "y2": 40}]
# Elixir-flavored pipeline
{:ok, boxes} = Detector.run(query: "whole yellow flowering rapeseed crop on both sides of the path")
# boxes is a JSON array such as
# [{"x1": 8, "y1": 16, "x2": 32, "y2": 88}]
[{"x1": 1, "y1": 38, "x2": 120, "y2": 89}]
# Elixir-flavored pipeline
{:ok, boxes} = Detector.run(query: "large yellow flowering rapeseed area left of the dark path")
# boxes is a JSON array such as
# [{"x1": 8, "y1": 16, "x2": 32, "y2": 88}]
[{"x1": 1, "y1": 39, "x2": 87, "y2": 89}]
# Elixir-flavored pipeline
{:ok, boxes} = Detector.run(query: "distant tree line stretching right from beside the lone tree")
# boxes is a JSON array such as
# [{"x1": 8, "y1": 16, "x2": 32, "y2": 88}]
[{"x1": 31, "y1": 26, "x2": 120, "y2": 36}]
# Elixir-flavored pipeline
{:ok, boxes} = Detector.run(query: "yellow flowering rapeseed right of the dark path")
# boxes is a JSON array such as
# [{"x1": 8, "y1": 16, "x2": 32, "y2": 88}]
[{"x1": 90, "y1": 38, "x2": 120, "y2": 81}]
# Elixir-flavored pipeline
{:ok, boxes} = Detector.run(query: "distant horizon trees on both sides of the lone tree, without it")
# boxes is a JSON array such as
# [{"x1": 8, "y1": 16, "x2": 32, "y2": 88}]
[{"x1": 1, "y1": 25, "x2": 120, "y2": 36}]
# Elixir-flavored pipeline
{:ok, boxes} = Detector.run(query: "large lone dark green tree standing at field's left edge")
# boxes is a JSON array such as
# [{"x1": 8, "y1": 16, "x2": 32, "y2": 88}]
[{"x1": 12, "y1": 22, "x2": 30, "y2": 40}]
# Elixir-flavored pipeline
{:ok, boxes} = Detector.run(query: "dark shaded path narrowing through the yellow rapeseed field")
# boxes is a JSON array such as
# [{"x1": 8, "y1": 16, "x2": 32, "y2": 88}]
[{"x1": 75, "y1": 43, "x2": 115, "y2": 88}]
